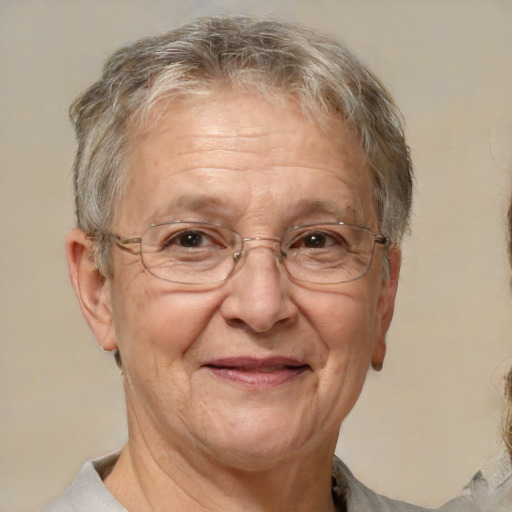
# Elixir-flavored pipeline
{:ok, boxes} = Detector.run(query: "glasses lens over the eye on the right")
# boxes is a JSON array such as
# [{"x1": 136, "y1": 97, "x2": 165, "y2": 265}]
[{"x1": 282, "y1": 224, "x2": 375, "y2": 284}]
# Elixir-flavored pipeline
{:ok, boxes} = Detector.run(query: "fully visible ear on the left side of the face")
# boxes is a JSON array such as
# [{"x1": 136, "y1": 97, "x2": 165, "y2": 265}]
[{"x1": 66, "y1": 229, "x2": 117, "y2": 351}]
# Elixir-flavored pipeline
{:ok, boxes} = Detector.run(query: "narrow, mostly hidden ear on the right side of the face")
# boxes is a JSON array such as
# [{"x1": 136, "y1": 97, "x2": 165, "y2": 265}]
[{"x1": 372, "y1": 247, "x2": 402, "y2": 371}]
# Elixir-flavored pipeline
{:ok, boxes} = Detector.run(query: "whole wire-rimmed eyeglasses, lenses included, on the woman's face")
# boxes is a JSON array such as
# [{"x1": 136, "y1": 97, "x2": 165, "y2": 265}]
[{"x1": 110, "y1": 220, "x2": 389, "y2": 285}]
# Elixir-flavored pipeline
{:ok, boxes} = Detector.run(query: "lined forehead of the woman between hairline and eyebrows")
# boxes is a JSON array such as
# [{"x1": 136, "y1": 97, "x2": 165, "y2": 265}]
[{"x1": 121, "y1": 90, "x2": 373, "y2": 230}]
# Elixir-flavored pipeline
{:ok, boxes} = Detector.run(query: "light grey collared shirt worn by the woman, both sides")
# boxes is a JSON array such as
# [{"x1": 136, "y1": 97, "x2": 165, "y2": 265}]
[{"x1": 41, "y1": 453, "x2": 512, "y2": 512}]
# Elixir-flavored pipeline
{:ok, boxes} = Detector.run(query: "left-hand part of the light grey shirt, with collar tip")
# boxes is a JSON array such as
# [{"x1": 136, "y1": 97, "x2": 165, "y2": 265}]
[{"x1": 41, "y1": 453, "x2": 126, "y2": 512}]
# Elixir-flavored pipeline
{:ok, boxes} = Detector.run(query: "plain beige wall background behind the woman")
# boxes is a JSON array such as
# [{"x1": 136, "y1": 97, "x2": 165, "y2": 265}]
[{"x1": 0, "y1": 0, "x2": 512, "y2": 512}]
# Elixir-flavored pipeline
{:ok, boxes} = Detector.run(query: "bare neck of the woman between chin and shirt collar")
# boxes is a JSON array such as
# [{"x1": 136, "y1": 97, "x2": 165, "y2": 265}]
[{"x1": 105, "y1": 424, "x2": 335, "y2": 512}]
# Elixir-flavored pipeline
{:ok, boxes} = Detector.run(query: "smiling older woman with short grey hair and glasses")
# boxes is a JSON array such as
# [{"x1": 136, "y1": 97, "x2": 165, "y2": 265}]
[{"x1": 45, "y1": 18, "x2": 477, "y2": 512}]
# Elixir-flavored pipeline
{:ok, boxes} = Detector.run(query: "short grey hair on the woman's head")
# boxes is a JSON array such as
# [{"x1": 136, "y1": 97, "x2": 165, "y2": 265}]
[{"x1": 70, "y1": 16, "x2": 412, "y2": 275}]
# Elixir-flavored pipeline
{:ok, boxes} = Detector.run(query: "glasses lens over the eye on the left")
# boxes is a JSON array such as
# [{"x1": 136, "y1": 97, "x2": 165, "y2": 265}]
[{"x1": 141, "y1": 221, "x2": 241, "y2": 284}]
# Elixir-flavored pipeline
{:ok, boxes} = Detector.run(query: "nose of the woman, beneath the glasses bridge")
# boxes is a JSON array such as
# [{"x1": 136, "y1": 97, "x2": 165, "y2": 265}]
[{"x1": 221, "y1": 238, "x2": 297, "y2": 333}]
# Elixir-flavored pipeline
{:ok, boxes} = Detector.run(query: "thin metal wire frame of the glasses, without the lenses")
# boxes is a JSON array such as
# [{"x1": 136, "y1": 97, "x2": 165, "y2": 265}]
[{"x1": 107, "y1": 220, "x2": 391, "y2": 286}]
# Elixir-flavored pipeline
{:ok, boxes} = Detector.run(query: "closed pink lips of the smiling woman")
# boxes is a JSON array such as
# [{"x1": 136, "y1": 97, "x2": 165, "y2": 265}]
[{"x1": 203, "y1": 357, "x2": 311, "y2": 387}]
